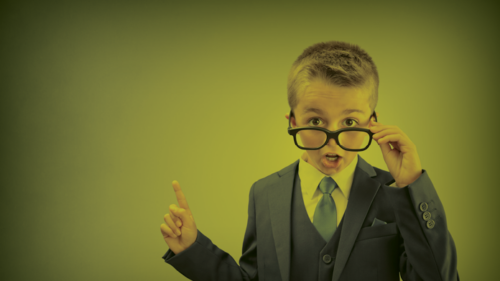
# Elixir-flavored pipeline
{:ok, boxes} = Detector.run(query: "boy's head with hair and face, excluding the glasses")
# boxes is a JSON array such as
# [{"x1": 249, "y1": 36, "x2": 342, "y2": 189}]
[{"x1": 288, "y1": 41, "x2": 378, "y2": 175}]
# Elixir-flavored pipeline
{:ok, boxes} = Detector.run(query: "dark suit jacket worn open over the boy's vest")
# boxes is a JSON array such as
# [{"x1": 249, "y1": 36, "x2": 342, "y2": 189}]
[{"x1": 163, "y1": 156, "x2": 459, "y2": 281}]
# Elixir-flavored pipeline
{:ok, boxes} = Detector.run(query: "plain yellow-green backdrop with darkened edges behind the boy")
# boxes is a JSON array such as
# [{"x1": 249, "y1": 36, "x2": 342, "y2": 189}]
[{"x1": 0, "y1": 1, "x2": 500, "y2": 280}]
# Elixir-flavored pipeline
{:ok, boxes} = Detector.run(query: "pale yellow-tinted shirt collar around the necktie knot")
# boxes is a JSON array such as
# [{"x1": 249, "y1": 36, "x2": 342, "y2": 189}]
[{"x1": 299, "y1": 152, "x2": 358, "y2": 200}]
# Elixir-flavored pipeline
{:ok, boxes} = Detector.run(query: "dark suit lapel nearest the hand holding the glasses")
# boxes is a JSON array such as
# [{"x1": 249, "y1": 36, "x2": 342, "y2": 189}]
[{"x1": 332, "y1": 156, "x2": 380, "y2": 281}]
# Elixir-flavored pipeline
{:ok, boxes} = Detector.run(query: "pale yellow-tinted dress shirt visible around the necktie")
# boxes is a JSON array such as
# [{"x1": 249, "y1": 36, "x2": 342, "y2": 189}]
[{"x1": 299, "y1": 153, "x2": 358, "y2": 226}]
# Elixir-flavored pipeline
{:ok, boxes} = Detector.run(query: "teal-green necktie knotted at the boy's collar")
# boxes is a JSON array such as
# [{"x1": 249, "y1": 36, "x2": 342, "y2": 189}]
[{"x1": 313, "y1": 177, "x2": 337, "y2": 242}]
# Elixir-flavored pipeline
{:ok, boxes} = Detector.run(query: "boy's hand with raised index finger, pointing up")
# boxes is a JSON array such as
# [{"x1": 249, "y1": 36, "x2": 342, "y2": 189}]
[{"x1": 160, "y1": 181, "x2": 198, "y2": 254}]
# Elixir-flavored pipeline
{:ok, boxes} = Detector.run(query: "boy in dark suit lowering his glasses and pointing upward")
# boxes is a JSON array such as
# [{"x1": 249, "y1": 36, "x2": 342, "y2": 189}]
[{"x1": 161, "y1": 41, "x2": 459, "y2": 281}]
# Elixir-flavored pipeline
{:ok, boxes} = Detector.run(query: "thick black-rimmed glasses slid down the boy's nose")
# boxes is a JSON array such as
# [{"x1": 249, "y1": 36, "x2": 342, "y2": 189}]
[{"x1": 288, "y1": 110, "x2": 377, "y2": 151}]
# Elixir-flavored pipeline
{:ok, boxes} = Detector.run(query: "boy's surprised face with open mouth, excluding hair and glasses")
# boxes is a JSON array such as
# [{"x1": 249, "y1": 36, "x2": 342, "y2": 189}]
[{"x1": 290, "y1": 80, "x2": 372, "y2": 175}]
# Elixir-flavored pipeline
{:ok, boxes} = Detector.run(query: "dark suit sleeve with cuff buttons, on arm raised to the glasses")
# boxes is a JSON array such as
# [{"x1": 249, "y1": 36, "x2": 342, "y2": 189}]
[{"x1": 386, "y1": 170, "x2": 460, "y2": 281}]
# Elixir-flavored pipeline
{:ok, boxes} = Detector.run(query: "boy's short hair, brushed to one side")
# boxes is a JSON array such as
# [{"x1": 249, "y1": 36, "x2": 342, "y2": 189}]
[{"x1": 288, "y1": 41, "x2": 378, "y2": 110}]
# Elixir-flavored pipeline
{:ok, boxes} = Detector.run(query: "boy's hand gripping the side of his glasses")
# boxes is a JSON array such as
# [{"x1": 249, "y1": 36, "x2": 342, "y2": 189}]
[{"x1": 369, "y1": 119, "x2": 422, "y2": 187}]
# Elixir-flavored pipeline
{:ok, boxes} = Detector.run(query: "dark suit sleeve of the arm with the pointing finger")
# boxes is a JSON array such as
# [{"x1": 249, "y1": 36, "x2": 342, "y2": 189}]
[{"x1": 163, "y1": 180, "x2": 258, "y2": 281}]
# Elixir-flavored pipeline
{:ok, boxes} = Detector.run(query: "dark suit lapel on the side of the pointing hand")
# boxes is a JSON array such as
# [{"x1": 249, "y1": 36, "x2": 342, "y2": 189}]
[{"x1": 268, "y1": 161, "x2": 299, "y2": 281}]
